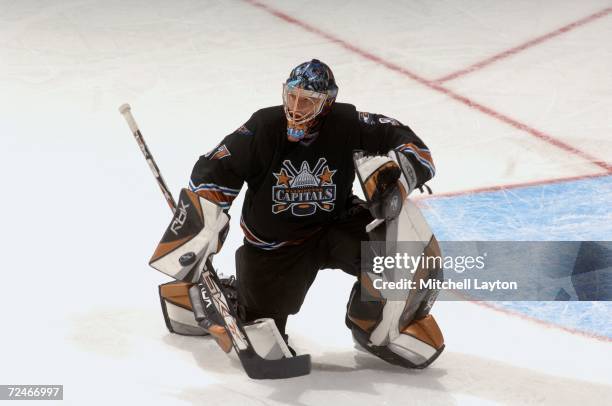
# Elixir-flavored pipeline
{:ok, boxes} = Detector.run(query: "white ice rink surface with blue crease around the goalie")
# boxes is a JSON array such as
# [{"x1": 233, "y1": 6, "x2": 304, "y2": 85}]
[{"x1": 0, "y1": 0, "x2": 612, "y2": 405}]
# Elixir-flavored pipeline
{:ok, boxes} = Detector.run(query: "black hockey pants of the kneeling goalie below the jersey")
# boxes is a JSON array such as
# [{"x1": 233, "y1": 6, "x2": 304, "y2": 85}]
[{"x1": 236, "y1": 210, "x2": 372, "y2": 334}]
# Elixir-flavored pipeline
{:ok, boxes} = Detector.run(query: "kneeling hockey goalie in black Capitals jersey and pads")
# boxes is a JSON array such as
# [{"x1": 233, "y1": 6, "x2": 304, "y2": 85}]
[{"x1": 150, "y1": 59, "x2": 444, "y2": 376}]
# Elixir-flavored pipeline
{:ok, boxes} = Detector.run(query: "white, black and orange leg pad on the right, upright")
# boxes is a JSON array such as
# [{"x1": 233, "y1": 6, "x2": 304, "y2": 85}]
[{"x1": 346, "y1": 191, "x2": 444, "y2": 368}]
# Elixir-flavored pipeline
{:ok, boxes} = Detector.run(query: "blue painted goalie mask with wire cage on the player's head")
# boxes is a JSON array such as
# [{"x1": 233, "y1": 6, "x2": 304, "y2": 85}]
[{"x1": 283, "y1": 59, "x2": 338, "y2": 142}]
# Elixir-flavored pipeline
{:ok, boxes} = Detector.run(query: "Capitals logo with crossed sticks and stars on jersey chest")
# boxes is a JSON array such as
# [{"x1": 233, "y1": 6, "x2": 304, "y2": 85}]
[{"x1": 272, "y1": 158, "x2": 336, "y2": 217}]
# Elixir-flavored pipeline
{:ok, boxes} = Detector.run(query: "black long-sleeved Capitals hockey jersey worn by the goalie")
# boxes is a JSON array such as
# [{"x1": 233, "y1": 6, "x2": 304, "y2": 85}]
[{"x1": 190, "y1": 103, "x2": 435, "y2": 249}]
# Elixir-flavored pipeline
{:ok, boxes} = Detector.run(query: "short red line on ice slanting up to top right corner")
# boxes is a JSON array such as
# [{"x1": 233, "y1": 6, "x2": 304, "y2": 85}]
[{"x1": 434, "y1": 8, "x2": 612, "y2": 83}]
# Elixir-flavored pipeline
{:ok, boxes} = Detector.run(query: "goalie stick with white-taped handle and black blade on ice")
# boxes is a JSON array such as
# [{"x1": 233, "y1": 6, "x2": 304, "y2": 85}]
[{"x1": 119, "y1": 103, "x2": 311, "y2": 379}]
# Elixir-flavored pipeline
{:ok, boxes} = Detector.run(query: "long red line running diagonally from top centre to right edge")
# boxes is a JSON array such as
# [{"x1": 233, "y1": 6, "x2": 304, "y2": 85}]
[{"x1": 243, "y1": 0, "x2": 612, "y2": 172}]
